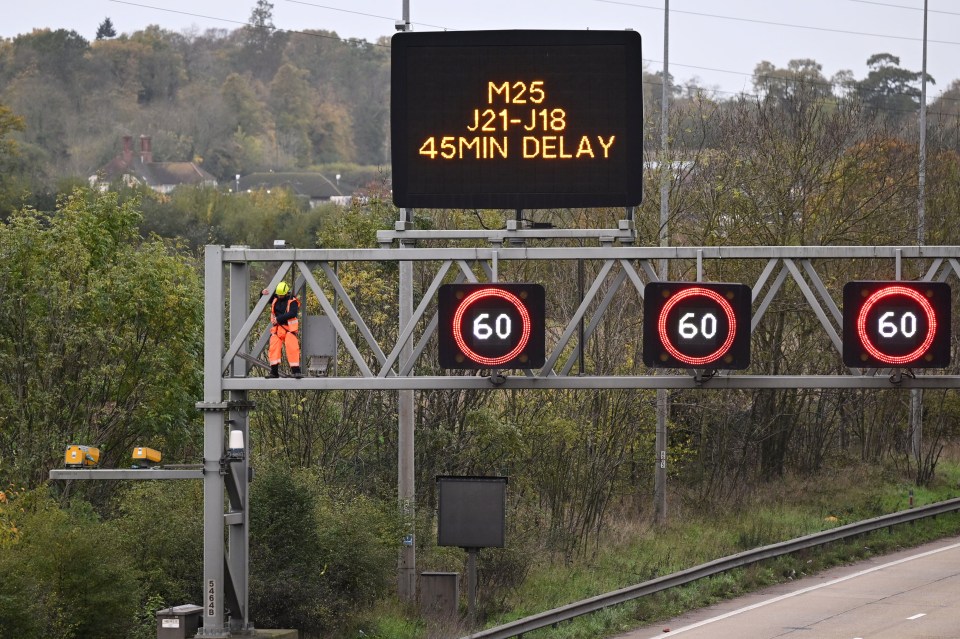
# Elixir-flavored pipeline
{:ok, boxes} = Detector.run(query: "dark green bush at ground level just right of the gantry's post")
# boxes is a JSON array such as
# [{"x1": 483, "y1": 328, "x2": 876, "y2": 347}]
[{"x1": 250, "y1": 463, "x2": 402, "y2": 637}]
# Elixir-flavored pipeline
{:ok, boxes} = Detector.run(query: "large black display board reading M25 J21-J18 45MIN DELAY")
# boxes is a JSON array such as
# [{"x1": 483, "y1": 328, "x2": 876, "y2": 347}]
[{"x1": 390, "y1": 31, "x2": 643, "y2": 209}]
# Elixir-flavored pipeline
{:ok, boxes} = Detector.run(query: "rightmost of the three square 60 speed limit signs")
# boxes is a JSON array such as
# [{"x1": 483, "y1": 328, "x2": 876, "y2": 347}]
[{"x1": 843, "y1": 281, "x2": 950, "y2": 368}]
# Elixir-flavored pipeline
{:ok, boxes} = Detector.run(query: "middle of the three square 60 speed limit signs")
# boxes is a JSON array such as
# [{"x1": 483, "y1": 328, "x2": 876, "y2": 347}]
[{"x1": 643, "y1": 282, "x2": 752, "y2": 369}]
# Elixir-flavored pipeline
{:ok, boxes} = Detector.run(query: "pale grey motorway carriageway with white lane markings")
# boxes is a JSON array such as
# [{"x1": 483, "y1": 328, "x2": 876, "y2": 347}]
[{"x1": 618, "y1": 537, "x2": 960, "y2": 639}]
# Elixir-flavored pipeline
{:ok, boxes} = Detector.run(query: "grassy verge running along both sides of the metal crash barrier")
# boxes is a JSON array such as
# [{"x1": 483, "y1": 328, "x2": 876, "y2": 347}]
[{"x1": 356, "y1": 460, "x2": 960, "y2": 639}]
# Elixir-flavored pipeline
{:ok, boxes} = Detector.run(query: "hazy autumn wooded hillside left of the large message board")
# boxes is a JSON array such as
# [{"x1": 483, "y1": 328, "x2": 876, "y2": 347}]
[{"x1": 0, "y1": 0, "x2": 390, "y2": 211}]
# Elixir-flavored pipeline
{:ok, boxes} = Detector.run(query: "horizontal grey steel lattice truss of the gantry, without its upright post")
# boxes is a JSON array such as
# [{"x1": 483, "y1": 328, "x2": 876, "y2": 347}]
[{"x1": 214, "y1": 239, "x2": 960, "y2": 391}]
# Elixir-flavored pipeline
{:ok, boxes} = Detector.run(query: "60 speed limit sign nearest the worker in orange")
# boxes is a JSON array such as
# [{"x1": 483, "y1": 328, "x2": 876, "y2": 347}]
[{"x1": 437, "y1": 284, "x2": 546, "y2": 369}]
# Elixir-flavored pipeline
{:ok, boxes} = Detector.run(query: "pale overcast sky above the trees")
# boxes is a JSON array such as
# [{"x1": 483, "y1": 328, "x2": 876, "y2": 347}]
[{"x1": 0, "y1": 0, "x2": 960, "y2": 100}]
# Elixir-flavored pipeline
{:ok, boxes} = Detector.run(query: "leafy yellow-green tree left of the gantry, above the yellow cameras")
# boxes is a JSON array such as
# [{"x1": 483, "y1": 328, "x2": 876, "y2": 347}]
[{"x1": 0, "y1": 190, "x2": 203, "y2": 485}]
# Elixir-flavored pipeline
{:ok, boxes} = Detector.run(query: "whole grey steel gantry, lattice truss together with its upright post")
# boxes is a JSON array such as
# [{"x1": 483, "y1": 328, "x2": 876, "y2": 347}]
[{"x1": 197, "y1": 235, "x2": 960, "y2": 637}]
